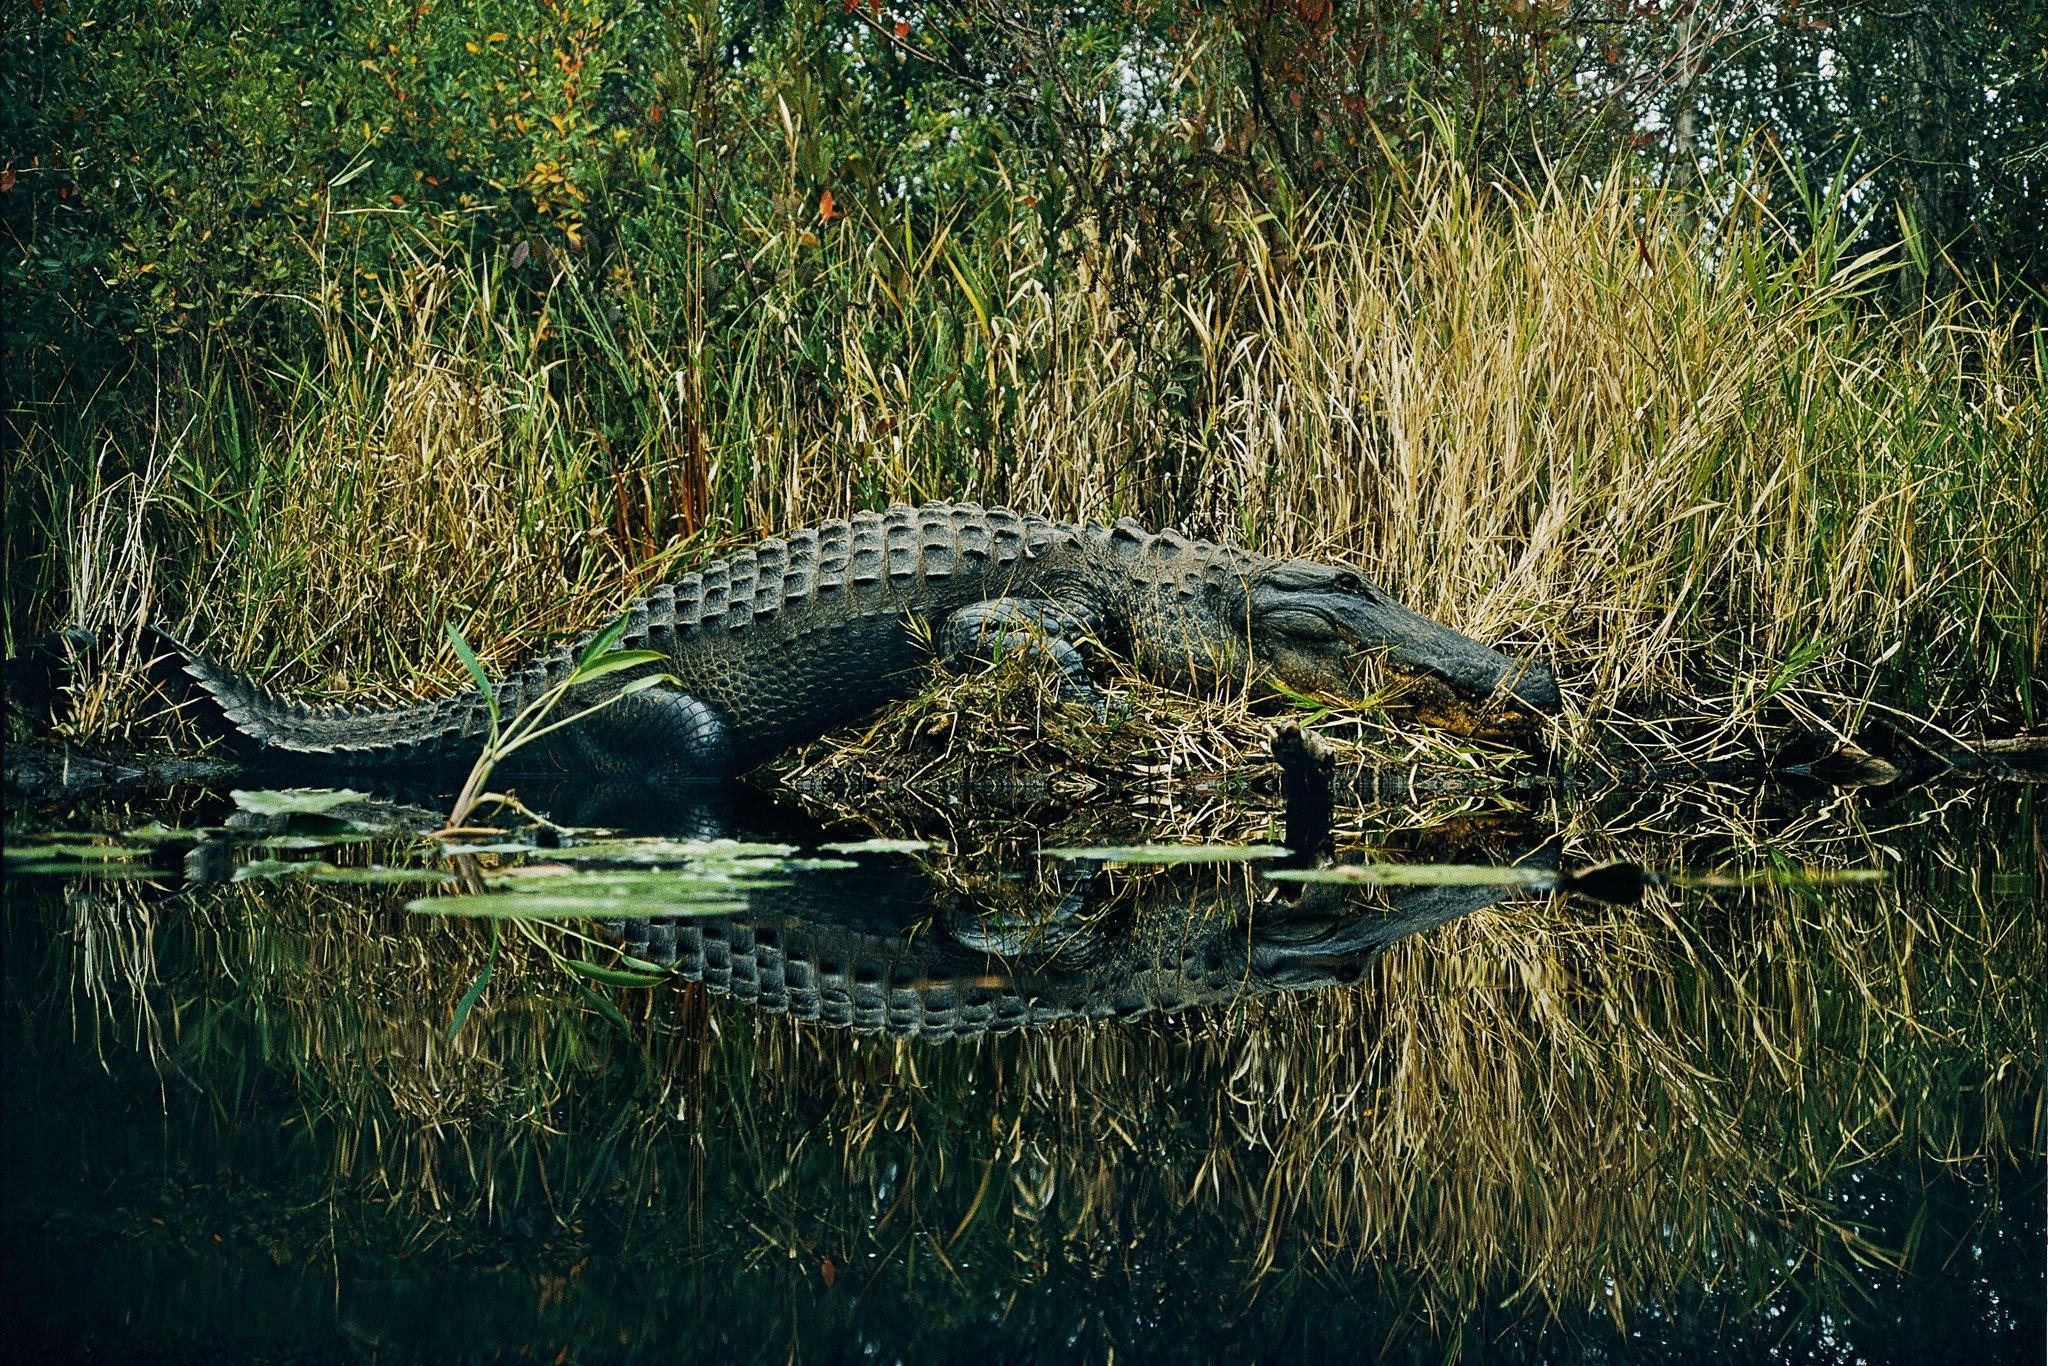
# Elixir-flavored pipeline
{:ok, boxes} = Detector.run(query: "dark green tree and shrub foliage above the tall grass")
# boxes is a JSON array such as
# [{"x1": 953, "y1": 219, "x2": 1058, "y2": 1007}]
[{"x1": 0, "y1": 0, "x2": 2048, "y2": 397}]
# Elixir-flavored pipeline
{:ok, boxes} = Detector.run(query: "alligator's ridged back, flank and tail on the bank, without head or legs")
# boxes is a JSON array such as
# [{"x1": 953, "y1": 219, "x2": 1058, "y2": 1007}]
[{"x1": 152, "y1": 504, "x2": 1128, "y2": 766}]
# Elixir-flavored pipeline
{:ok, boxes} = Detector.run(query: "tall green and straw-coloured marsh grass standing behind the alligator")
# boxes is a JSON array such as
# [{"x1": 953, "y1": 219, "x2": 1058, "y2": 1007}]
[{"x1": 8, "y1": 164, "x2": 2048, "y2": 774}]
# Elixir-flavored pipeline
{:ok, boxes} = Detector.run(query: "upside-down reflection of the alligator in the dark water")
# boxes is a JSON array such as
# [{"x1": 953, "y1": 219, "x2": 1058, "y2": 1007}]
[{"x1": 608, "y1": 850, "x2": 1554, "y2": 1040}]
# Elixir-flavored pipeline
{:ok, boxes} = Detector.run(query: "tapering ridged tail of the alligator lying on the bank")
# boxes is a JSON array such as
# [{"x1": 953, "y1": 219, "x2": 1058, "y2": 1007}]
[{"x1": 141, "y1": 627, "x2": 487, "y2": 764}]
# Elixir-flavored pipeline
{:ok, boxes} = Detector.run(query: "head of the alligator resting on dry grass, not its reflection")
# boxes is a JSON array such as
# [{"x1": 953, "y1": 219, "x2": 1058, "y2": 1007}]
[{"x1": 1247, "y1": 559, "x2": 1559, "y2": 729}]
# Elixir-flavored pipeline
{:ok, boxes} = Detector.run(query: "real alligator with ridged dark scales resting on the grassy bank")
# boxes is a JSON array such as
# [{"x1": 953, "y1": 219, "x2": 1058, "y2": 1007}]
[{"x1": 150, "y1": 504, "x2": 1559, "y2": 778}]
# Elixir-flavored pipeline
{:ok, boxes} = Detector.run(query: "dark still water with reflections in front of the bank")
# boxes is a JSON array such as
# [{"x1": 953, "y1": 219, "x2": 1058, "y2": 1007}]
[{"x1": 0, "y1": 774, "x2": 2048, "y2": 1362}]
